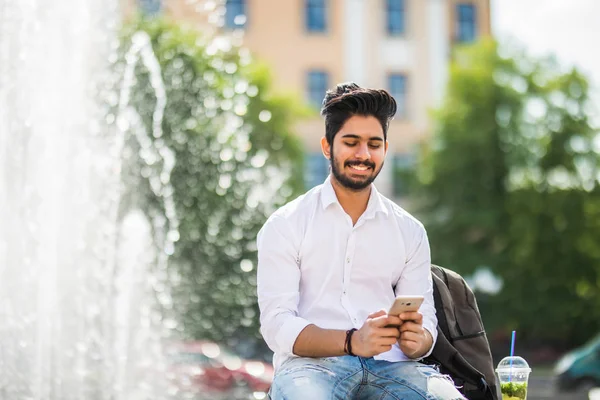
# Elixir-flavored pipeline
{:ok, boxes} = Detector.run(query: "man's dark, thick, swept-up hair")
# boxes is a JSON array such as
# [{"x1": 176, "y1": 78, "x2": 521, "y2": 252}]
[{"x1": 321, "y1": 82, "x2": 396, "y2": 145}]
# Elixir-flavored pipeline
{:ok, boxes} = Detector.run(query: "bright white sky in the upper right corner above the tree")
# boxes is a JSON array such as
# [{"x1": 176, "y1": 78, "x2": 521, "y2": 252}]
[{"x1": 491, "y1": 0, "x2": 600, "y2": 88}]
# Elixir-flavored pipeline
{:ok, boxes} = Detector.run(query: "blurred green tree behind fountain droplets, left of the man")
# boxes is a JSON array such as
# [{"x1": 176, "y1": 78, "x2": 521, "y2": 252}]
[{"x1": 119, "y1": 19, "x2": 303, "y2": 356}]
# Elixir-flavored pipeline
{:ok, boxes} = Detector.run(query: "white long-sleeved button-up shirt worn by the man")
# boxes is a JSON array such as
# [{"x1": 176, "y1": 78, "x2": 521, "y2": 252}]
[{"x1": 257, "y1": 178, "x2": 437, "y2": 368}]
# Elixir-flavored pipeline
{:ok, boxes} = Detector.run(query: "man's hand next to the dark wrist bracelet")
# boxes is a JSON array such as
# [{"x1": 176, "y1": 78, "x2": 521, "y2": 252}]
[{"x1": 352, "y1": 310, "x2": 402, "y2": 357}]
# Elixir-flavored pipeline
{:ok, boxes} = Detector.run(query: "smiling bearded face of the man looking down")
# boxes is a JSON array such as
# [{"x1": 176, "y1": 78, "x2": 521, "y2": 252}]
[{"x1": 321, "y1": 115, "x2": 388, "y2": 191}]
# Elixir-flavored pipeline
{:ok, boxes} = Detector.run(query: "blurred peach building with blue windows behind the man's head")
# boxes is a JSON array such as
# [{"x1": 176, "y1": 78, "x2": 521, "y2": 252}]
[{"x1": 127, "y1": 0, "x2": 490, "y2": 197}]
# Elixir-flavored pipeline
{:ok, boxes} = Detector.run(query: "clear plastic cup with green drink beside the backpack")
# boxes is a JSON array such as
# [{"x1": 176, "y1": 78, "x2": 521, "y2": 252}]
[{"x1": 496, "y1": 356, "x2": 531, "y2": 400}]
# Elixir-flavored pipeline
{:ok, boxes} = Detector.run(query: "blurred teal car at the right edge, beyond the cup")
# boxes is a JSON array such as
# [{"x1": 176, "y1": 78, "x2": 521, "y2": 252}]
[{"x1": 554, "y1": 334, "x2": 600, "y2": 392}]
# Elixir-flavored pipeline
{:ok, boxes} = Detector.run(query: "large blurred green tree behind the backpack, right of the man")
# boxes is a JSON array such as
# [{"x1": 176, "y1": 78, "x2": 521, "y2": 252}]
[{"x1": 414, "y1": 41, "x2": 600, "y2": 346}]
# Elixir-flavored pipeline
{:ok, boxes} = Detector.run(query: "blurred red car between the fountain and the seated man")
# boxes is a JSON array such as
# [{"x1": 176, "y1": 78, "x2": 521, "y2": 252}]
[{"x1": 167, "y1": 341, "x2": 274, "y2": 400}]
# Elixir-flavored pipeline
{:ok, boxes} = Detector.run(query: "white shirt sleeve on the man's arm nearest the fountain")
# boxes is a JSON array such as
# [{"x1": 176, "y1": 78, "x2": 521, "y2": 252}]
[{"x1": 257, "y1": 217, "x2": 310, "y2": 354}]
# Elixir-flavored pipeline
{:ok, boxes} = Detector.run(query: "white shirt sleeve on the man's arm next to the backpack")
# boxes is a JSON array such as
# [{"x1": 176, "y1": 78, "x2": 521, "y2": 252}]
[{"x1": 396, "y1": 226, "x2": 437, "y2": 359}]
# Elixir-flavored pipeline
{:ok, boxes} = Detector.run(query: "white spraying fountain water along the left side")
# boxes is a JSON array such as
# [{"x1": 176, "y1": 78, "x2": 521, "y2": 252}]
[{"x1": 0, "y1": 0, "x2": 178, "y2": 400}]
